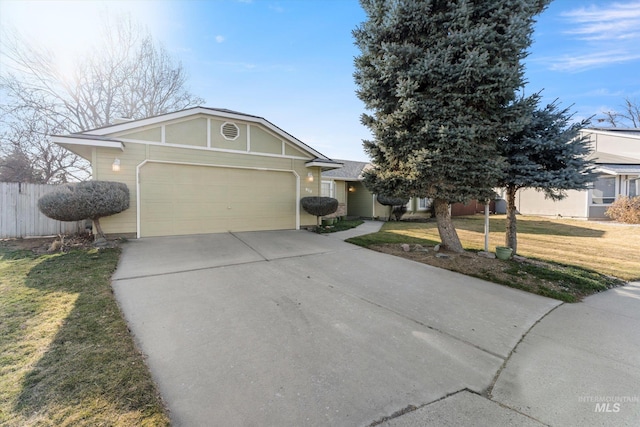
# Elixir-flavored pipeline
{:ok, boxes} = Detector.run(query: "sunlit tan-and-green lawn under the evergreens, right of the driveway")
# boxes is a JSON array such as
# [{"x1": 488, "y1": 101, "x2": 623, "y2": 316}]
[{"x1": 349, "y1": 215, "x2": 640, "y2": 301}]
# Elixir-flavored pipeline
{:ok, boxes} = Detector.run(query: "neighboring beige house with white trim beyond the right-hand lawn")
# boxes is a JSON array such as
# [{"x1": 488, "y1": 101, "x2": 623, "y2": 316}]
[{"x1": 516, "y1": 128, "x2": 640, "y2": 220}]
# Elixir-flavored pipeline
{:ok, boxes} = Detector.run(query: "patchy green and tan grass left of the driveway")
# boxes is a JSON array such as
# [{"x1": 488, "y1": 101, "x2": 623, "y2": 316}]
[{"x1": 0, "y1": 248, "x2": 169, "y2": 426}]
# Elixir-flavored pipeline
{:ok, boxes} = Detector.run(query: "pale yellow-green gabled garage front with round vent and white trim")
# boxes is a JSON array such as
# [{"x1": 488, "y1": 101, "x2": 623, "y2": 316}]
[{"x1": 52, "y1": 107, "x2": 340, "y2": 237}]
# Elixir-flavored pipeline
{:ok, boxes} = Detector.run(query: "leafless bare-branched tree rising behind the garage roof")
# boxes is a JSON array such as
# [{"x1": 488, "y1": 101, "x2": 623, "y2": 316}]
[{"x1": 0, "y1": 17, "x2": 204, "y2": 182}]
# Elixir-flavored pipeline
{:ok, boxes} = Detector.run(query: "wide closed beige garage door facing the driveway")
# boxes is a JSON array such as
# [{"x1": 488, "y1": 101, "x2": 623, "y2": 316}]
[{"x1": 140, "y1": 163, "x2": 297, "y2": 237}]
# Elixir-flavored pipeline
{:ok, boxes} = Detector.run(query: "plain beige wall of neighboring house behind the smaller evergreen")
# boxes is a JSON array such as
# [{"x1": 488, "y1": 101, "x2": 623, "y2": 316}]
[{"x1": 516, "y1": 189, "x2": 588, "y2": 218}]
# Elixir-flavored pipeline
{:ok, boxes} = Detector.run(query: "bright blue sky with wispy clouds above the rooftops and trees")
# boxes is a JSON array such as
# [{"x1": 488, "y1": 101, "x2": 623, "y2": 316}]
[{"x1": 0, "y1": 0, "x2": 640, "y2": 161}]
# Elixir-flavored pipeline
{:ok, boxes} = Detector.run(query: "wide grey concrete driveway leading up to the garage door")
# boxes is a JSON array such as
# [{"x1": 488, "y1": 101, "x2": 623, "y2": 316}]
[{"x1": 113, "y1": 231, "x2": 640, "y2": 426}]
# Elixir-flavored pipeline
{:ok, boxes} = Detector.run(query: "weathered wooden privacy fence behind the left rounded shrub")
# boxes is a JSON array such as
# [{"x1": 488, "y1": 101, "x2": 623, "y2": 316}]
[{"x1": 0, "y1": 182, "x2": 84, "y2": 239}]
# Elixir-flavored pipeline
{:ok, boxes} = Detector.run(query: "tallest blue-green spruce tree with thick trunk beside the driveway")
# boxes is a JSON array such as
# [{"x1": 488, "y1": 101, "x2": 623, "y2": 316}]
[{"x1": 353, "y1": 0, "x2": 548, "y2": 251}]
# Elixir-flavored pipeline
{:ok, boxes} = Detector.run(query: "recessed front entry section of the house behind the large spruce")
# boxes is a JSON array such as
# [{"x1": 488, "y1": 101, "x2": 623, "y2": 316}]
[{"x1": 321, "y1": 160, "x2": 494, "y2": 219}]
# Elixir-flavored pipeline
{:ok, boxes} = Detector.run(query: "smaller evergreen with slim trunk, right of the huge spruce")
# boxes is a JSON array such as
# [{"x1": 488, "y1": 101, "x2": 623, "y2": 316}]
[{"x1": 500, "y1": 94, "x2": 596, "y2": 253}]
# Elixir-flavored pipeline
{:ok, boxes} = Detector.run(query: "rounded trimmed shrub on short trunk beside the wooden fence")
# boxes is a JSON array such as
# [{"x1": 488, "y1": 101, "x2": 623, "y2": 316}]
[{"x1": 38, "y1": 181, "x2": 129, "y2": 238}]
